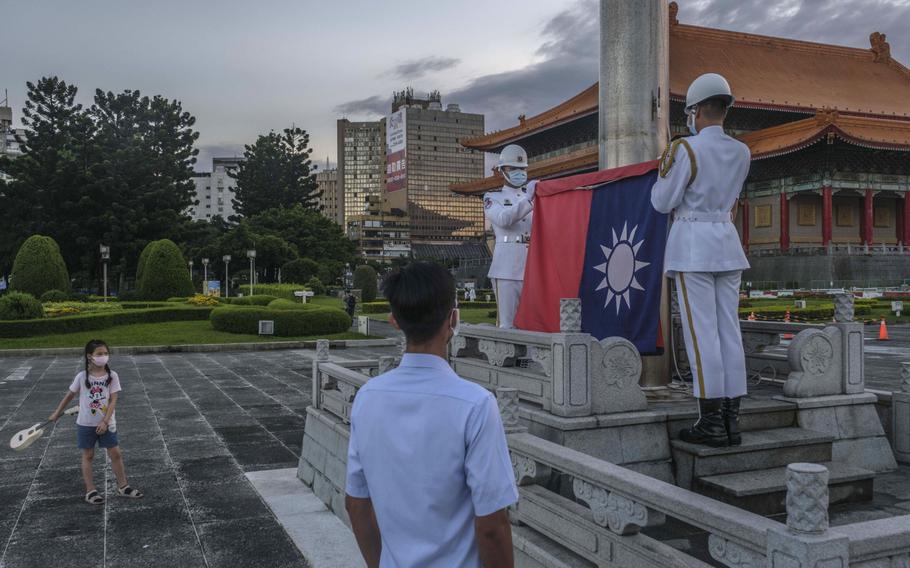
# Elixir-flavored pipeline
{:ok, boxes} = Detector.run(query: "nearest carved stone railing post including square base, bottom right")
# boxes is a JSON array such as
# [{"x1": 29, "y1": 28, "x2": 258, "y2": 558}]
[{"x1": 767, "y1": 463, "x2": 850, "y2": 568}]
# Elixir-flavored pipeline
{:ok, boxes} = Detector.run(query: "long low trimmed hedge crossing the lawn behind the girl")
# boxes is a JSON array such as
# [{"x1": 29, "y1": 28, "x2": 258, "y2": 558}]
[{"x1": 0, "y1": 307, "x2": 213, "y2": 337}]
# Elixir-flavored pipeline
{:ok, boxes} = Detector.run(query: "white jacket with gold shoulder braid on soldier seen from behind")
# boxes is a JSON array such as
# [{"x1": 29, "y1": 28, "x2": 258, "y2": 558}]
[{"x1": 651, "y1": 126, "x2": 751, "y2": 276}]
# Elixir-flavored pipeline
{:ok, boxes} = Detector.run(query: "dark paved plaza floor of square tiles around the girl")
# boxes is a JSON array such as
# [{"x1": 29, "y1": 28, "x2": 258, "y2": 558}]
[{"x1": 0, "y1": 349, "x2": 389, "y2": 568}]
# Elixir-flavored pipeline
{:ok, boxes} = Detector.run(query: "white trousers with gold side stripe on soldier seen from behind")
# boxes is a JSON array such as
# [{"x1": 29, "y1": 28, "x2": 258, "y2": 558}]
[{"x1": 676, "y1": 270, "x2": 746, "y2": 398}]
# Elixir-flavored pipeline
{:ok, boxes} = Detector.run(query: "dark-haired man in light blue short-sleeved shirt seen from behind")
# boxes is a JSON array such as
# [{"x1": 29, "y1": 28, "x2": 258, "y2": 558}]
[{"x1": 345, "y1": 263, "x2": 518, "y2": 568}]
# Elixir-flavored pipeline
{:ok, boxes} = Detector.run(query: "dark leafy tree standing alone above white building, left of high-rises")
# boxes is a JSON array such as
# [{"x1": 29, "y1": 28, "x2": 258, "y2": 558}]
[{"x1": 230, "y1": 127, "x2": 321, "y2": 217}]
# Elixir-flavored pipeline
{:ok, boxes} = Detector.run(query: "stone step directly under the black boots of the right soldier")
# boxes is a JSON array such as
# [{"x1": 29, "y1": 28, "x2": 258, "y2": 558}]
[{"x1": 670, "y1": 428, "x2": 834, "y2": 489}]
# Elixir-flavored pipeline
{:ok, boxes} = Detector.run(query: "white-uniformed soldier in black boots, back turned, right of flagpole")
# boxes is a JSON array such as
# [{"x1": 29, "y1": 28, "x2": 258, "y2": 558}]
[{"x1": 651, "y1": 73, "x2": 751, "y2": 446}]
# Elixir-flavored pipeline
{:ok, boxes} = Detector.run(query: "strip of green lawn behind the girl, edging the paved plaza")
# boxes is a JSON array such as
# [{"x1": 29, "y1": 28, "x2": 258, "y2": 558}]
[{"x1": 0, "y1": 320, "x2": 367, "y2": 349}]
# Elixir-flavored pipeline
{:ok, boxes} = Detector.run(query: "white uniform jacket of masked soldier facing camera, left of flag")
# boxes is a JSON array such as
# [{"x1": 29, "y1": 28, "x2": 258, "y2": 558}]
[{"x1": 483, "y1": 182, "x2": 534, "y2": 280}]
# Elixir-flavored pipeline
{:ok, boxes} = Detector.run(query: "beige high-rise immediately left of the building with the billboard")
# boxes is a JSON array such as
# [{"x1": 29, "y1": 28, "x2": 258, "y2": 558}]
[{"x1": 336, "y1": 118, "x2": 385, "y2": 228}]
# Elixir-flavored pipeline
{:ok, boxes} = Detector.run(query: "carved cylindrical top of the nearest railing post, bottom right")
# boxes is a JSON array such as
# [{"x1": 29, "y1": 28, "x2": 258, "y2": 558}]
[{"x1": 787, "y1": 463, "x2": 828, "y2": 534}]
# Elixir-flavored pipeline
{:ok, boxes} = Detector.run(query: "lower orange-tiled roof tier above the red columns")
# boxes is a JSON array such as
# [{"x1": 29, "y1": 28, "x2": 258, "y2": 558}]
[{"x1": 739, "y1": 110, "x2": 910, "y2": 160}]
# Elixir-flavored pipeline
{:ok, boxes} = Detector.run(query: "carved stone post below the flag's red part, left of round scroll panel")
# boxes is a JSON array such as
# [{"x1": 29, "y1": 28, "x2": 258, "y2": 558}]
[{"x1": 550, "y1": 298, "x2": 596, "y2": 416}]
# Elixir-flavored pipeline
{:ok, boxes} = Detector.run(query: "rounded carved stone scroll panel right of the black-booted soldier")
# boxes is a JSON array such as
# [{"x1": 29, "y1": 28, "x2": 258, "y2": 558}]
[{"x1": 784, "y1": 327, "x2": 844, "y2": 398}]
